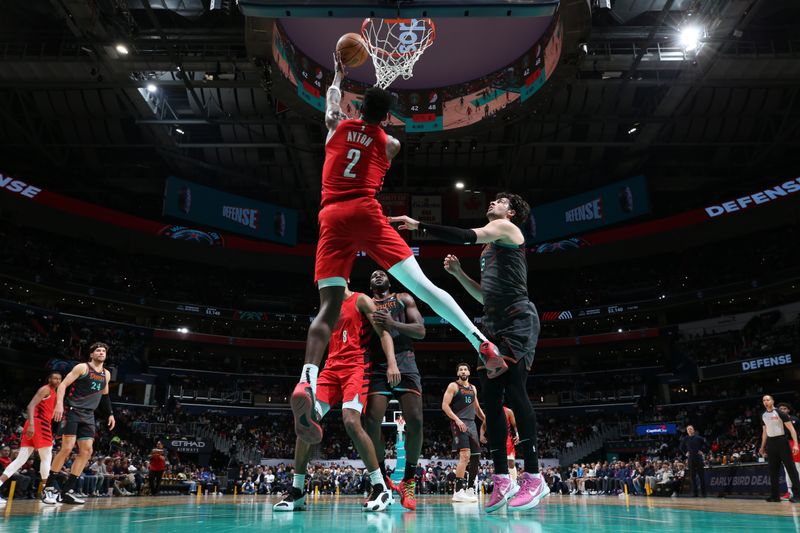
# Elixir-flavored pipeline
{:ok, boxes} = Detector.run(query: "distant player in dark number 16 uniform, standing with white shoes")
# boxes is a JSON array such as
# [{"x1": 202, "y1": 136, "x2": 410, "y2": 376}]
[{"x1": 442, "y1": 363, "x2": 486, "y2": 503}]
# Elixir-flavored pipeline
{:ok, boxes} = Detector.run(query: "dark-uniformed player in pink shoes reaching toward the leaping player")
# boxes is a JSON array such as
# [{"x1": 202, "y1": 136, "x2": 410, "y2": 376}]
[{"x1": 390, "y1": 193, "x2": 550, "y2": 513}]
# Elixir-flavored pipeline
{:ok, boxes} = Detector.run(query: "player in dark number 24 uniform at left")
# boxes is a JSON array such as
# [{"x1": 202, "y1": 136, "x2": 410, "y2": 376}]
[{"x1": 45, "y1": 342, "x2": 116, "y2": 504}]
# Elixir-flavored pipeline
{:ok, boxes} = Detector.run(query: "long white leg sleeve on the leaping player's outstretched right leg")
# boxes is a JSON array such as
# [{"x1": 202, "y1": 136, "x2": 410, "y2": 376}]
[{"x1": 389, "y1": 256, "x2": 486, "y2": 351}]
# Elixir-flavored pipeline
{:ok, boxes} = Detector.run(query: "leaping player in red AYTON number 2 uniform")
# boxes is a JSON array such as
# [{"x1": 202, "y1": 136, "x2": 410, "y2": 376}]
[{"x1": 291, "y1": 56, "x2": 508, "y2": 444}]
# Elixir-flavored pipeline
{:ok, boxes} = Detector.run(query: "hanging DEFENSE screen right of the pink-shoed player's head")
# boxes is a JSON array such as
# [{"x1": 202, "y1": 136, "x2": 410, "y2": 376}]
[{"x1": 529, "y1": 176, "x2": 650, "y2": 243}]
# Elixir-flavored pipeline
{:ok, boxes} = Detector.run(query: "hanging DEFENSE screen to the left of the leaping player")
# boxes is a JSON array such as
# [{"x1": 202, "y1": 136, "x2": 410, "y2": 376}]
[{"x1": 164, "y1": 176, "x2": 297, "y2": 245}]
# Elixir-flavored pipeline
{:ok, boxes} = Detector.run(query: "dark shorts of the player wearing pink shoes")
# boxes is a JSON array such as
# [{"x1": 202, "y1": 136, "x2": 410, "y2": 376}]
[{"x1": 478, "y1": 300, "x2": 541, "y2": 370}]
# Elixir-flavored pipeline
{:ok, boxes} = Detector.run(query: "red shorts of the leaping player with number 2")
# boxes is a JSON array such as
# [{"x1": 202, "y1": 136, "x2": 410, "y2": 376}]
[{"x1": 314, "y1": 198, "x2": 413, "y2": 283}]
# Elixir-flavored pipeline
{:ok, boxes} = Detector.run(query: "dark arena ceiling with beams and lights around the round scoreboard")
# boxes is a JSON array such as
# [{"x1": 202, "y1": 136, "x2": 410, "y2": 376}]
[{"x1": 0, "y1": 0, "x2": 800, "y2": 235}]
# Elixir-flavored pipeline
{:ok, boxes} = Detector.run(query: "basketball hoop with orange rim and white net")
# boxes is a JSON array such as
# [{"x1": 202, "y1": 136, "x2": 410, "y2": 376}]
[{"x1": 361, "y1": 18, "x2": 436, "y2": 89}]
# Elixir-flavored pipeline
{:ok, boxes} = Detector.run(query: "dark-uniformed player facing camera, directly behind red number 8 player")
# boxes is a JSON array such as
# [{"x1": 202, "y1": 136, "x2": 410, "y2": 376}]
[{"x1": 364, "y1": 270, "x2": 425, "y2": 510}]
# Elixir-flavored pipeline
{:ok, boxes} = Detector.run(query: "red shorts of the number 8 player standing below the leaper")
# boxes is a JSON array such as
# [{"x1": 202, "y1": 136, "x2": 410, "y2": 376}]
[{"x1": 317, "y1": 360, "x2": 369, "y2": 413}]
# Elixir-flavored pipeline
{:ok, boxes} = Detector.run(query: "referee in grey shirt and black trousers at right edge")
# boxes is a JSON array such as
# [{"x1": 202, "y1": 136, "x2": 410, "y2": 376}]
[{"x1": 759, "y1": 394, "x2": 800, "y2": 503}]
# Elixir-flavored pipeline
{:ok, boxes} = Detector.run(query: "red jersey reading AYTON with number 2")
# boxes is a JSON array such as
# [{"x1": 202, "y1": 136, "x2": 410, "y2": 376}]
[{"x1": 322, "y1": 120, "x2": 391, "y2": 207}]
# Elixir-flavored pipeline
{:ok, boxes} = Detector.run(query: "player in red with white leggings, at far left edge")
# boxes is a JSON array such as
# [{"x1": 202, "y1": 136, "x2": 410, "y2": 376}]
[{"x1": 0, "y1": 372, "x2": 61, "y2": 504}]
